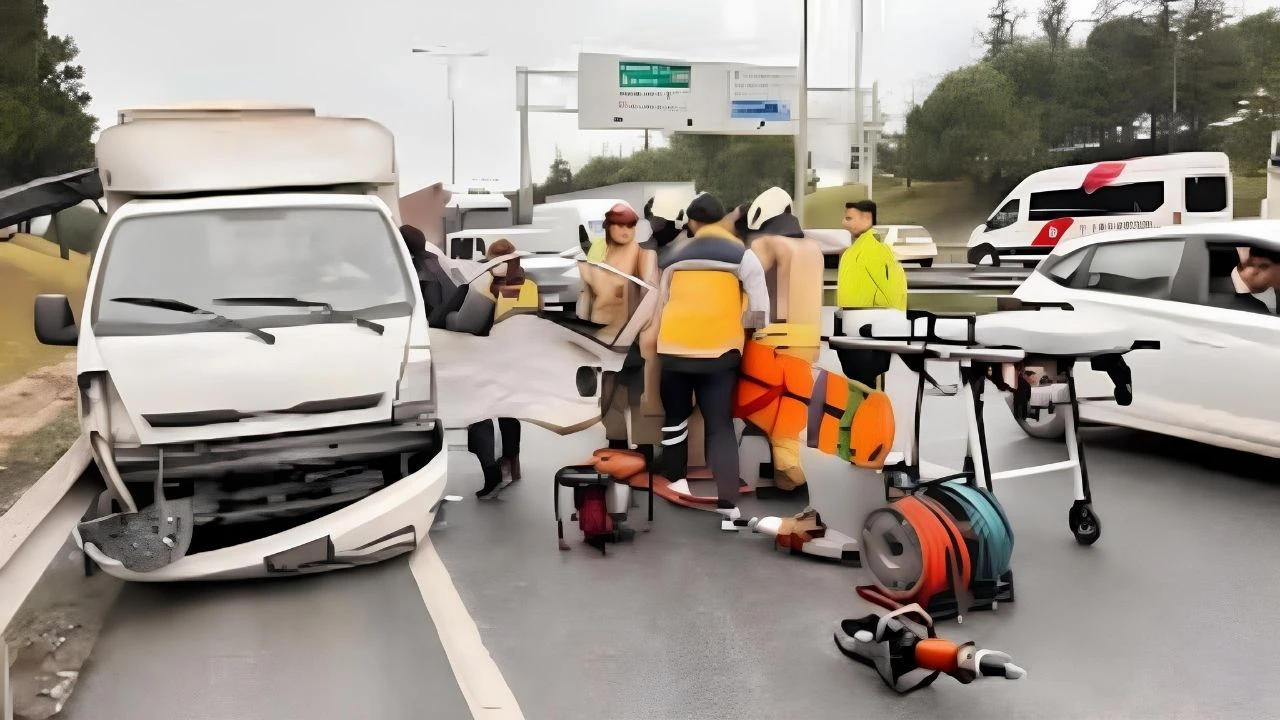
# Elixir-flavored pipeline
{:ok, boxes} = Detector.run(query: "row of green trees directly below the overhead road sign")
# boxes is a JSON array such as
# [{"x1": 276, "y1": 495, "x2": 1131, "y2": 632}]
[{"x1": 548, "y1": 135, "x2": 795, "y2": 208}]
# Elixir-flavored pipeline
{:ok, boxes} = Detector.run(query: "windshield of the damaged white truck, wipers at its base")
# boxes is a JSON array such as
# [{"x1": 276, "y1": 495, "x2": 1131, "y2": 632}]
[{"x1": 92, "y1": 208, "x2": 413, "y2": 332}]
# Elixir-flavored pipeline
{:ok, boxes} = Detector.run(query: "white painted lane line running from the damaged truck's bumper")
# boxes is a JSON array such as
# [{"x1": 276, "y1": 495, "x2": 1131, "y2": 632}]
[{"x1": 408, "y1": 537, "x2": 525, "y2": 720}]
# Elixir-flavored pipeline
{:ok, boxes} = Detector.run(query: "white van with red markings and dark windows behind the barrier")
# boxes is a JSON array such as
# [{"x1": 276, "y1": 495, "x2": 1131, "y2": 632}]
[{"x1": 968, "y1": 152, "x2": 1234, "y2": 265}]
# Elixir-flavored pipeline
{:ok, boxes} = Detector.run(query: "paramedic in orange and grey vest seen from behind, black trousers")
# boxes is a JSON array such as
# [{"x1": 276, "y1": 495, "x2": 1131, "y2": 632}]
[{"x1": 658, "y1": 192, "x2": 769, "y2": 529}]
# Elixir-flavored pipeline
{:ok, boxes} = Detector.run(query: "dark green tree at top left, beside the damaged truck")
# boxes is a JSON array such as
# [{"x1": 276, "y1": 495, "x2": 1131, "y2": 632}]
[{"x1": 0, "y1": 0, "x2": 97, "y2": 187}]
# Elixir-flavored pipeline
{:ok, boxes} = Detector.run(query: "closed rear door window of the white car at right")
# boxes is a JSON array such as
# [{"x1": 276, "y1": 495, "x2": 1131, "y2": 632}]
[{"x1": 1084, "y1": 240, "x2": 1183, "y2": 300}]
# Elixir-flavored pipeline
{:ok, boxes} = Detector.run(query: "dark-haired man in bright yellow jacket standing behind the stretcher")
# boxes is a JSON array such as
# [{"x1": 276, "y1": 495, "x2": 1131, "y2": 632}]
[{"x1": 836, "y1": 200, "x2": 906, "y2": 388}]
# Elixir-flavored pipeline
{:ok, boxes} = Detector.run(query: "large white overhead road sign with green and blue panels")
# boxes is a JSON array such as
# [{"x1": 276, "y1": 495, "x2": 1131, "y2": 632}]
[{"x1": 577, "y1": 53, "x2": 800, "y2": 135}]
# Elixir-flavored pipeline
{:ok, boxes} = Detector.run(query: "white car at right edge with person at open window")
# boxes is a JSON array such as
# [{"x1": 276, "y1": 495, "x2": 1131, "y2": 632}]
[{"x1": 1014, "y1": 220, "x2": 1280, "y2": 457}]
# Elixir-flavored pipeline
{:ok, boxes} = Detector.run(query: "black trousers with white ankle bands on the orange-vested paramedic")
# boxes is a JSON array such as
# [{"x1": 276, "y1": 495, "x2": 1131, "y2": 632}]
[{"x1": 660, "y1": 356, "x2": 741, "y2": 506}]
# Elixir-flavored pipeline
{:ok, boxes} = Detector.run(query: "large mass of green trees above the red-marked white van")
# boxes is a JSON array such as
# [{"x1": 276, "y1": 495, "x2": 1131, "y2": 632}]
[{"x1": 895, "y1": 0, "x2": 1280, "y2": 183}]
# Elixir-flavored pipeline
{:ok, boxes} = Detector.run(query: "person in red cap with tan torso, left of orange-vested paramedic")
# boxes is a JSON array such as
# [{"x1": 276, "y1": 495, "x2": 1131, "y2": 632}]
[{"x1": 577, "y1": 202, "x2": 662, "y2": 450}]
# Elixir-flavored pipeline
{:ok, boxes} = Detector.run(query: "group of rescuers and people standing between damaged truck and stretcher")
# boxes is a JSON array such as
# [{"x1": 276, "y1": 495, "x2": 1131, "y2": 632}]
[{"x1": 401, "y1": 188, "x2": 906, "y2": 520}]
